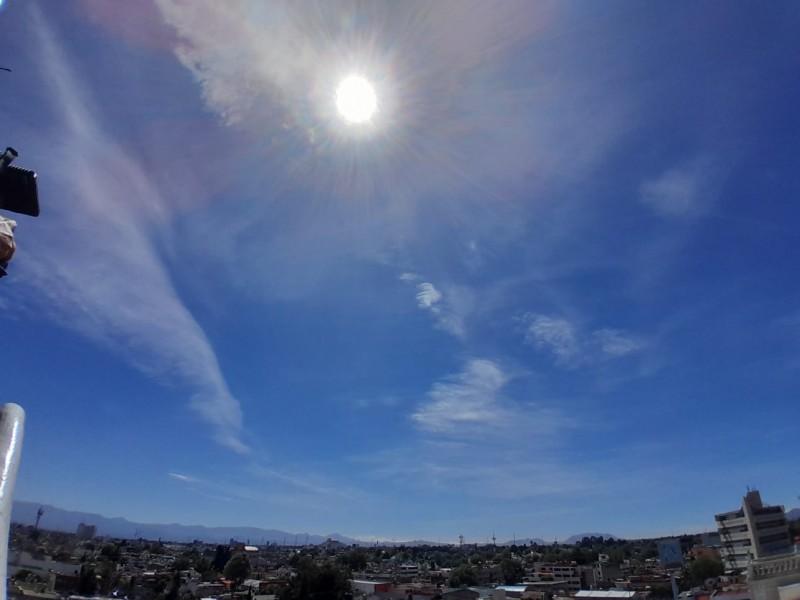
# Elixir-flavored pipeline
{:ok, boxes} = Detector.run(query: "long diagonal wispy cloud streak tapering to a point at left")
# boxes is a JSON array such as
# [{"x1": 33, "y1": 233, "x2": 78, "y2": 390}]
[{"x1": 18, "y1": 10, "x2": 247, "y2": 452}]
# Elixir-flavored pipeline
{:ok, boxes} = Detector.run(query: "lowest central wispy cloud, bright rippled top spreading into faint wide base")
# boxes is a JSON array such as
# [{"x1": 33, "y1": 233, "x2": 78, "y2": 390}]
[{"x1": 361, "y1": 358, "x2": 593, "y2": 500}]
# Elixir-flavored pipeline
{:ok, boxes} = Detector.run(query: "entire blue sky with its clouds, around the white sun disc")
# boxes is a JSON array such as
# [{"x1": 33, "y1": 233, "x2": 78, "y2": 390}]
[{"x1": 0, "y1": 0, "x2": 800, "y2": 542}]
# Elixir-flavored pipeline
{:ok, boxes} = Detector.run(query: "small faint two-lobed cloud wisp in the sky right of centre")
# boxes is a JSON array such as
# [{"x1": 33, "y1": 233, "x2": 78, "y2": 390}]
[{"x1": 523, "y1": 313, "x2": 647, "y2": 368}]
